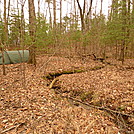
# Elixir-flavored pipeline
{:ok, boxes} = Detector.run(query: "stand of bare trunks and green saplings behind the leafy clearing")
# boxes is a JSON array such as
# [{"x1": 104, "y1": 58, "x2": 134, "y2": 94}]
[{"x1": 0, "y1": 0, "x2": 134, "y2": 65}]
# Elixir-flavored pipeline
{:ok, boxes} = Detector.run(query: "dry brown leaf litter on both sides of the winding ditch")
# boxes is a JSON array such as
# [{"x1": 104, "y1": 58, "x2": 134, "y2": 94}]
[{"x1": 0, "y1": 57, "x2": 134, "y2": 134}]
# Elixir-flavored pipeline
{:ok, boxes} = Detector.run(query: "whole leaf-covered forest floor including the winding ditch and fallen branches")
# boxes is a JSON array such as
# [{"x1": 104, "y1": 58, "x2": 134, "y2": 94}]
[{"x1": 0, "y1": 55, "x2": 134, "y2": 134}]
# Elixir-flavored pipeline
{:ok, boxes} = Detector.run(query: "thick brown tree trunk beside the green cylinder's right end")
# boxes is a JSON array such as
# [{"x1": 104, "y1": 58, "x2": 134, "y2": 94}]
[{"x1": 28, "y1": 0, "x2": 36, "y2": 65}]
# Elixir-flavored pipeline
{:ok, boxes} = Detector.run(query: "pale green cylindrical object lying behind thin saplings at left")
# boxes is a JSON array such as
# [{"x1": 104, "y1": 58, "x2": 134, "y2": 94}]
[{"x1": 0, "y1": 50, "x2": 29, "y2": 65}]
